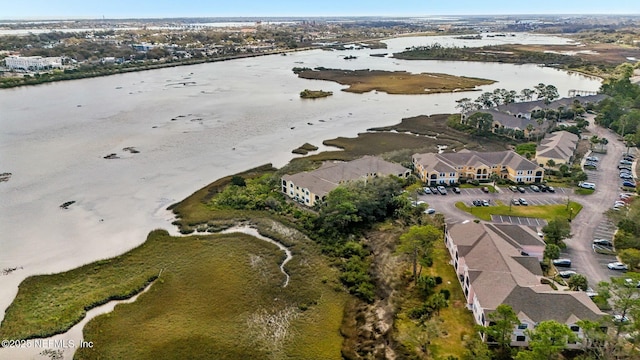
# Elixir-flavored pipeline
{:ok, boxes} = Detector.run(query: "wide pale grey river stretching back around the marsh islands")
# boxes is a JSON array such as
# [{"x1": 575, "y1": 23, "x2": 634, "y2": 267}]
[{"x1": 0, "y1": 34, "x2": 600, "y2": 358}]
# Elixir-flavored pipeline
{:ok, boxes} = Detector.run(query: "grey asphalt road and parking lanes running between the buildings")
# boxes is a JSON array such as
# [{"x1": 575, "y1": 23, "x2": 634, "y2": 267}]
[{"x1": 419, "y1": 119, "x2": 626, "y2": 288}]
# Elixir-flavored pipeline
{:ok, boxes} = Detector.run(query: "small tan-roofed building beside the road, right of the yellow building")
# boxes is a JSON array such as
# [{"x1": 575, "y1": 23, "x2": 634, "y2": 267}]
[{"x1": 535, "y1": 131, "x2": 580, "y2": 167}]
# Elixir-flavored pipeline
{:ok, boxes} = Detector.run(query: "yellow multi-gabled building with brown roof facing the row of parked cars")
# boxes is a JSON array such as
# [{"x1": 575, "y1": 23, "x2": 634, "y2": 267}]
[{"x1": 412, "y1": 150, "x2": 544, "y2": 185}]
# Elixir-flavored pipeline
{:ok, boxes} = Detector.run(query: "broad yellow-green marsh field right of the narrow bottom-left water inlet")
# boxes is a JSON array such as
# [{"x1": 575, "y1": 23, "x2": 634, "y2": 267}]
[{"x1": 76, "y1": 232, "x2": 345, "y2": 359}]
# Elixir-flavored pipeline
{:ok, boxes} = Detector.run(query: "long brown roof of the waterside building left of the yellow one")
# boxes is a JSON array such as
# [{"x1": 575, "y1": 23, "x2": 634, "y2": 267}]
[{"x1": 282, "y1": 156, "x2": 408, "y2": 196}]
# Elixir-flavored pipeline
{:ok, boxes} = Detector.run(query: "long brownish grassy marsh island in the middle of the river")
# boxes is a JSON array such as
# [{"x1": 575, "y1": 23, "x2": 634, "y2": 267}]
[{"x1": 293, "y1": 67, "x2": 495, "y2": 95}]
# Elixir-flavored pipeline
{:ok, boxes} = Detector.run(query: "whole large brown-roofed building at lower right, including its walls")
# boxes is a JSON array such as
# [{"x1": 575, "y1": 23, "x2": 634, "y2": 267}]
[{"x1": 445, "y1": 222, "x2": 606, "y2": 349}]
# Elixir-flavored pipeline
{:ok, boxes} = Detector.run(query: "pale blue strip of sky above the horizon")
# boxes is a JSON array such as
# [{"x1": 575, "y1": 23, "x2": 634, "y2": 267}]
[{"x1": 0, "y1": 0, "x2": 640, "y2": 20}]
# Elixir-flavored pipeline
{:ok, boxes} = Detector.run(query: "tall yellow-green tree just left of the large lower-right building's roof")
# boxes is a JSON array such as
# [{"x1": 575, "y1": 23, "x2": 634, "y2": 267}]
[{"x1": 397, "y1": 225, "x2": 443, "y2": 283}]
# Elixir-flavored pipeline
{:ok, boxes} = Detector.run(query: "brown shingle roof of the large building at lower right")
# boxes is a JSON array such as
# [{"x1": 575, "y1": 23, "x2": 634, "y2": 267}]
[{"x1": 448, "y1": 223, "x2": 604, "y2": 324}]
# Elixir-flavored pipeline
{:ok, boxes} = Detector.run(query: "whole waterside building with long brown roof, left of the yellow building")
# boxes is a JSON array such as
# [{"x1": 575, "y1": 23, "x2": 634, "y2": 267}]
[{"x1": 281, "y1": 156, "x2": 411, "y2": 206}]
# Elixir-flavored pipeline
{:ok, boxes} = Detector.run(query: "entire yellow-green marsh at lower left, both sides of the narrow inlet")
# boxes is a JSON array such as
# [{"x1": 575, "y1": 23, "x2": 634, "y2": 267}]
[{"x1": 0, "y1": 230, "x2": 346, "y2": 359}]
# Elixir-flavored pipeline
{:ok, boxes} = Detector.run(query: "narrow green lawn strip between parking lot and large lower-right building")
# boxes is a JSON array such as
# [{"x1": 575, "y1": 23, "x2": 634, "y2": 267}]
[{"x1": 456, "y1": 201, "x2": 582, "y2": 221}]
